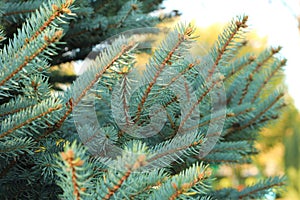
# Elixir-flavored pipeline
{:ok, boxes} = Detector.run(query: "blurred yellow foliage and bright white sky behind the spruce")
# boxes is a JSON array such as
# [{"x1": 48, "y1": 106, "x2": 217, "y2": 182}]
[{"x1": 50, "y1": 0, "x2": 300, "y2": 200}]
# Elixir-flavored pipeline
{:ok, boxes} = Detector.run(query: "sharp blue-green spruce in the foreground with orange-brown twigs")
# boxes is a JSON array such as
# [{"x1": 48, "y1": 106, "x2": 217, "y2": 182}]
[{"x1": 0, "y1": 0, "x2": 286, "y2": 199}]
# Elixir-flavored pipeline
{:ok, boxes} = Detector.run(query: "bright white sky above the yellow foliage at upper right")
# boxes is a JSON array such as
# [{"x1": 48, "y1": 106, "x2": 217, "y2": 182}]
[{"x1": 163, "y1": 0, "x2": 300, "y2": 110}]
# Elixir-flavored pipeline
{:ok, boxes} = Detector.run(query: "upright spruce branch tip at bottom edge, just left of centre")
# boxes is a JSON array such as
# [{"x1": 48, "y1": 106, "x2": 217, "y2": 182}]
[{"x1": 95, "y1": 141, "x2": 167, "y2": 199}]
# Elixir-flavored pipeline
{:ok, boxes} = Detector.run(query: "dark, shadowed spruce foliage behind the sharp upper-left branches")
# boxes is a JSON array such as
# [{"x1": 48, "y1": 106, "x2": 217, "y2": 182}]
[{"x1": 0, "y1": 0, "x2": 162, "y2": 64}]
